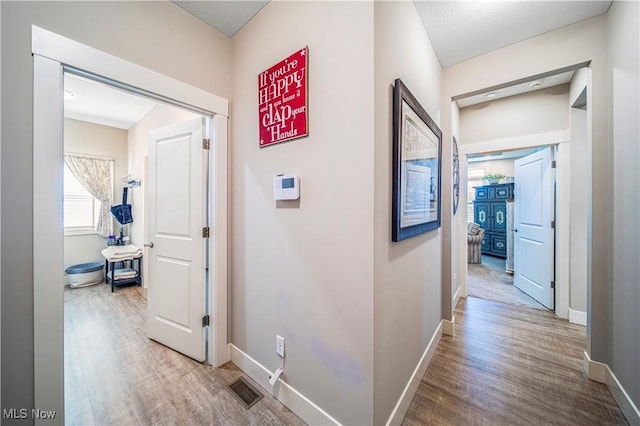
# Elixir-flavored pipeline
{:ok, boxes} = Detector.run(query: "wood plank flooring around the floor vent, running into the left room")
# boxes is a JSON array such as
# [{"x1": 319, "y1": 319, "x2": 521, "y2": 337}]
[{"x1": 64, "y1": 284, "x2": 304, "y2": 425}]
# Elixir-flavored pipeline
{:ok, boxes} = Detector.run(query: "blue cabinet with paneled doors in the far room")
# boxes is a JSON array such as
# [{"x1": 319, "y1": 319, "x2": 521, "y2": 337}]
[{"x1": 473, "y1": 183, "x2": 514, "y2": 258}]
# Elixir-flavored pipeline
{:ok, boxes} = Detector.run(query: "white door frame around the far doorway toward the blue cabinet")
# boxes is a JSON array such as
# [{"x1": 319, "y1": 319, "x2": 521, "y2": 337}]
[{"x1": 458, "y1": 130, "x2": 571, "y2": 319}]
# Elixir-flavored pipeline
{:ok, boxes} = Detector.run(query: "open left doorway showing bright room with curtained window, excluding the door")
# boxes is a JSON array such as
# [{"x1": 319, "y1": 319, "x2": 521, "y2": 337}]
[{"x1": 63, "y1": 73, "x2": 210, "y2": 424}]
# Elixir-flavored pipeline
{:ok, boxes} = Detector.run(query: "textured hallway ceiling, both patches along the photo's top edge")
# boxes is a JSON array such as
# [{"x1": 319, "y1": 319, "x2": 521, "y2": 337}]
[{"x1": 172, "y1": 0, "x2": 612, "y2": 68}]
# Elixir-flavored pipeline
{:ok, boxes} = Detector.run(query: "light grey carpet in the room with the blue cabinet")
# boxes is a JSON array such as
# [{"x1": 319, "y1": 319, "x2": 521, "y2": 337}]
[{"x1": 467, "y1": 255, "x2": 548, "y2": 310}]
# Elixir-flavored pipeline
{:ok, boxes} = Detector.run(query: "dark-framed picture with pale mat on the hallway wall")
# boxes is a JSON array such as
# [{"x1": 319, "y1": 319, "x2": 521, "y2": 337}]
[{"x1": 391, "y1": 79, "x2": 442, "y2": 241}]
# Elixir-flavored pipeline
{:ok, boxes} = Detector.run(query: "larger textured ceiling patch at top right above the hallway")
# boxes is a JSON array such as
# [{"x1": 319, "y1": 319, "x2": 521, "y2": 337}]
[{"x1": 414, "y1": 0, "x2": 612, "y2": 68}]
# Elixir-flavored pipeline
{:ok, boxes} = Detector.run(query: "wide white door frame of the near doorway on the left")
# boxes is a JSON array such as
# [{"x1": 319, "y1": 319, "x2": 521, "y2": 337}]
[{"x1": 31, "y1": 26, "x2": 229, "y2": 423}]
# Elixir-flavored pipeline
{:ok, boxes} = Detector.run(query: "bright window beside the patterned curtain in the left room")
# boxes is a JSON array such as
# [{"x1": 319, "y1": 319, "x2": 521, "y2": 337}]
[{"x1": 63, "y1": 165, "x2": 100, "y2": 234}]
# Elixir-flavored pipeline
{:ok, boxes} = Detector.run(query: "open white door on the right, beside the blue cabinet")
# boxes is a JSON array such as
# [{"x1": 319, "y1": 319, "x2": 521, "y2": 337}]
[{"x1": 514, "y1": 148, "x2": 555, "y2": 309}]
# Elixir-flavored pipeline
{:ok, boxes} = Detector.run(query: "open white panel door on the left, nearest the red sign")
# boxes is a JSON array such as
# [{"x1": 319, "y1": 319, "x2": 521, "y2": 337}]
[{"x1": 147, "y1": 118, "x2": 208, "y2": 361}]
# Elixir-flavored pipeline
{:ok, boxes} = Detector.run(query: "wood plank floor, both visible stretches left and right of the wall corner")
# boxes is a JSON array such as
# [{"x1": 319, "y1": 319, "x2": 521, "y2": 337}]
[{"x1": 65, "y1": 284, "x2": 627, "y2": 426}]
